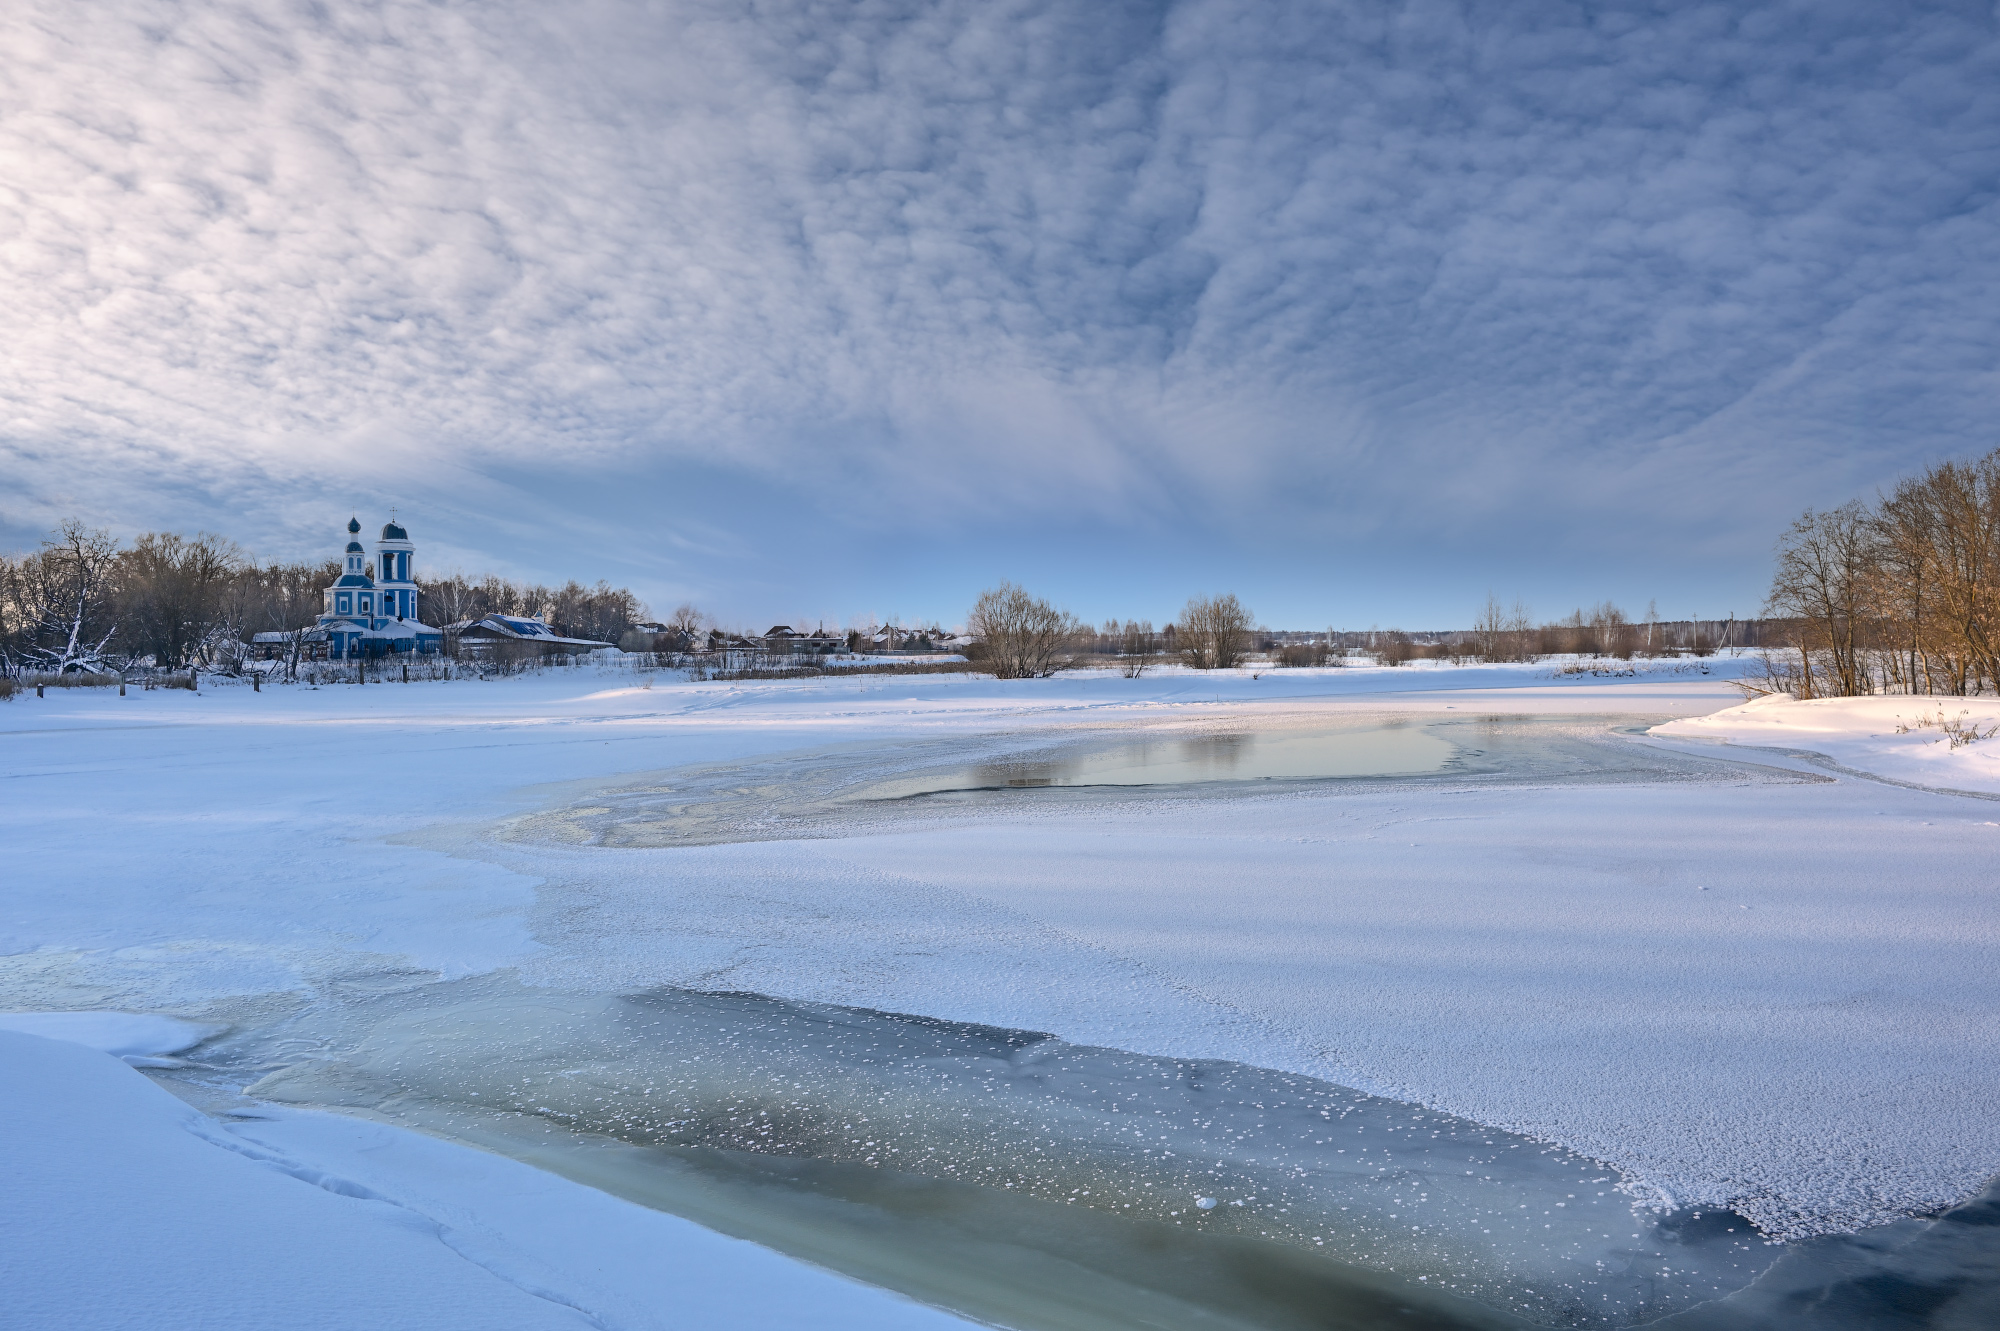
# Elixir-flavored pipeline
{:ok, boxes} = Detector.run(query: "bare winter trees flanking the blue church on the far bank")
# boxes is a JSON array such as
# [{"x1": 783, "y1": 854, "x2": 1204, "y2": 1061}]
[{"x1": 0, "y1": 522, "x2": 644, "y2": 673}]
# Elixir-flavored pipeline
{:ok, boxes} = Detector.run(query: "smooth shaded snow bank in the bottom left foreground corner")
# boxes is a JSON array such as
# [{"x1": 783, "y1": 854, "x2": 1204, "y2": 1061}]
[{"x1": 0, "y1": 1031, "x2": 968, "y2": 1331}]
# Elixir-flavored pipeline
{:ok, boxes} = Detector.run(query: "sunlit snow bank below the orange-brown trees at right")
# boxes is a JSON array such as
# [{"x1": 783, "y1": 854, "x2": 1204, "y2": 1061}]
[{"x1": 1652, "y1": 695, "x2": 2000, "y2": 795}]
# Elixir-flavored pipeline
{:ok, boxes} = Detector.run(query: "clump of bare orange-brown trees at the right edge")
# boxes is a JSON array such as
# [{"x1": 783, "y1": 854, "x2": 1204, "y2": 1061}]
[{"x1": 1766, "y1": 450, "x2": 2000, "y2": 697}]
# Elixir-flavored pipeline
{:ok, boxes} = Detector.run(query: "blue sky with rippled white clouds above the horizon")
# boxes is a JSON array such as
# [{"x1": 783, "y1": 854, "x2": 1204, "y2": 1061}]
[{"x1": 0, "y1": 0, "x2": 2000, "y2": 628}]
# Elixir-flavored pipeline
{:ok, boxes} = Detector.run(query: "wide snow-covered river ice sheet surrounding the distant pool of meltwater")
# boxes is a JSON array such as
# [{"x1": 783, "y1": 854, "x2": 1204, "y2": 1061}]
[{"x1": 0, "y1": 669, "x2": 2000, "y2": 1287}]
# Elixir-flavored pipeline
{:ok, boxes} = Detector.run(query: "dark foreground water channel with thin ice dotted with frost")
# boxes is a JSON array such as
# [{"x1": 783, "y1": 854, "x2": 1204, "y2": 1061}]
[{"x1": 170, "y1": 977, "x2": 2000, "y2": 1331}]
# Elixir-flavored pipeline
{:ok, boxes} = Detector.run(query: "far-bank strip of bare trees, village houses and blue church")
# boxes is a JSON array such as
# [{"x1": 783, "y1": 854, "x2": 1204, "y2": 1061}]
[{"x1": 0, "y1": 503, "x2": 1782, "y2": 679}]
